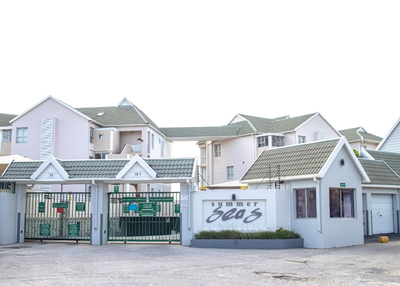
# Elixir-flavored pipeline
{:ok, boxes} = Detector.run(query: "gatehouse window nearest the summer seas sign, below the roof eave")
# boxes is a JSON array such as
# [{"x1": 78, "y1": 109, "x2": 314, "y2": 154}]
[{"x1": 296, "y1": 189, "x2": 317, "y2": 218}]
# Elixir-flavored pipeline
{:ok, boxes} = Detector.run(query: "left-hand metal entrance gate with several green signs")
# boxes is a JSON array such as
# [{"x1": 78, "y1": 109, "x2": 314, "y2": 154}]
[{"x1": 25, "y1": 192, "x2": 90, "y2": 240}]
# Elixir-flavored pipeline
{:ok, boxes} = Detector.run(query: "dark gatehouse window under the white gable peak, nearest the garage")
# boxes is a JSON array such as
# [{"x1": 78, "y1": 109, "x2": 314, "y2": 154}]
[{"x1": 329, "y1": 189, "x2": 354, "y2": 217}]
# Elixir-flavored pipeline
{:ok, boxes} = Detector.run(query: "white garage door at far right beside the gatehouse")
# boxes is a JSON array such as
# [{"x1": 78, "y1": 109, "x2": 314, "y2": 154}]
[{"x1": 371, "y1": 195, "x2": 394, "y2": 234}]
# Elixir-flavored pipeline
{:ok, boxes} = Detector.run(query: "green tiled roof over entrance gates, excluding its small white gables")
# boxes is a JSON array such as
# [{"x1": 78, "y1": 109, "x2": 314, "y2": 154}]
[{"x1": 0, "y1": 158, "x2": 194, "y2": 180}]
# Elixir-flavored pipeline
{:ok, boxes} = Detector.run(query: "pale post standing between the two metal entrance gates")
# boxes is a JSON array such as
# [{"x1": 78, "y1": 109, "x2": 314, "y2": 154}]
[{"x1": 90, "y1": 181, "x2": 108, "y2": 245}]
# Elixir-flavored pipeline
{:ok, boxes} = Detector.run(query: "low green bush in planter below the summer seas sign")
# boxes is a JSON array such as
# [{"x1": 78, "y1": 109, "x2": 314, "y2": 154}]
[{"x1": 194, "y1": 228, "x2": 301, "y2": 239}]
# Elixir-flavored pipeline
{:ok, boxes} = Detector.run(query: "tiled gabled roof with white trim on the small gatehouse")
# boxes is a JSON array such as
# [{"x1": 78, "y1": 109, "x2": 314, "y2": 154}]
[{"x1": 240, "y1": 137, "x2": 368, "y2": 182}]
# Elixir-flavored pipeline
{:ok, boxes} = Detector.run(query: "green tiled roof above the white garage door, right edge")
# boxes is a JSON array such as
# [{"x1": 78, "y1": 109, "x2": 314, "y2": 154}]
[{"x1": 359, "y1": 159, "x2": 400, "y2": 186}]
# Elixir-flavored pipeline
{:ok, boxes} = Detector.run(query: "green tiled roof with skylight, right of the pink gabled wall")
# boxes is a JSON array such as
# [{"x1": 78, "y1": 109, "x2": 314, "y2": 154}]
[{"x1": 75, "y1": 106, "x2": 159, "y2": 129}]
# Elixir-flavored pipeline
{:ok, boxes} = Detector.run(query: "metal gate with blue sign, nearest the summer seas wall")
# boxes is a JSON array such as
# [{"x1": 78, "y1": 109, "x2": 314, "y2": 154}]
[{"x1": 108, "y1": 192, "x2": 180, "y2": 242}]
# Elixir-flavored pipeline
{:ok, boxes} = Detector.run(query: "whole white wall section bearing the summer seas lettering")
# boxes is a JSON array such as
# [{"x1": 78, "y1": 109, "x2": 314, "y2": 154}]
[{"x1": 191, "y1": 189, "x2": 291, "y2": 237}]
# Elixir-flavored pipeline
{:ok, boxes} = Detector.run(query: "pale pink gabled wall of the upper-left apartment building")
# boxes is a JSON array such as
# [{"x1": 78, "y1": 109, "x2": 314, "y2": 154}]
[{"x1": 11, "y1": 98, "x2": 89, "y2": 160}]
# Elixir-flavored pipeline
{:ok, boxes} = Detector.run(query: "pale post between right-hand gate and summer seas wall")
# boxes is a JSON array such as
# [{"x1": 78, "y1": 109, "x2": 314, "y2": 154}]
[{"x1": 180, "y1": 182, "x2": 193, "y2": 245}]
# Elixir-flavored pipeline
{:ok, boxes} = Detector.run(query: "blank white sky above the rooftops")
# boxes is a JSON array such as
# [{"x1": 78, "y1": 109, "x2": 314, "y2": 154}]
[{"x1": 0, "y1": 0, "x2": 400, "y2": 156}]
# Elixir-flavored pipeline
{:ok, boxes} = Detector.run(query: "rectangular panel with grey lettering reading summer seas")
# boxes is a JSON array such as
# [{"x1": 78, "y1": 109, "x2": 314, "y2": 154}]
[{"x1": 203, "y1": 200, "x2": 266, "y2": 230}]
